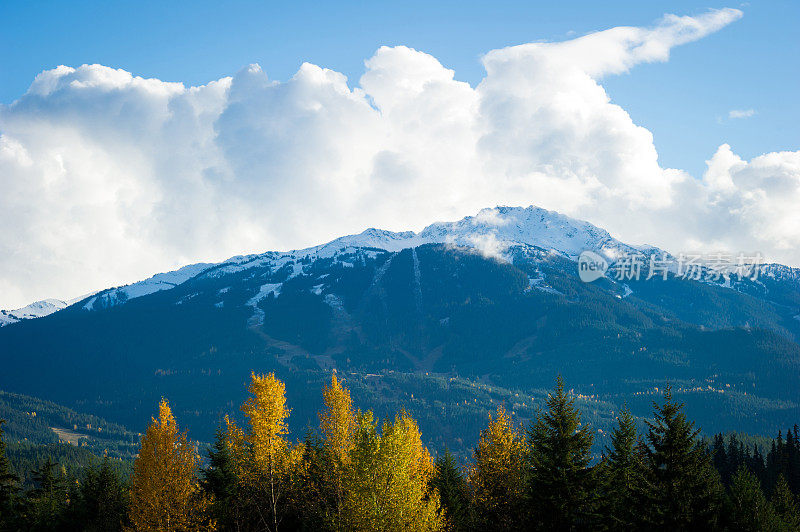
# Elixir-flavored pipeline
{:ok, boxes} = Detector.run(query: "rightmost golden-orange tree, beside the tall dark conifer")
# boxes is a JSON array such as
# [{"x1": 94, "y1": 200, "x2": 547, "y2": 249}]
[{"x1": 469, "y1": 407, "x2": 525, "y2": 530}]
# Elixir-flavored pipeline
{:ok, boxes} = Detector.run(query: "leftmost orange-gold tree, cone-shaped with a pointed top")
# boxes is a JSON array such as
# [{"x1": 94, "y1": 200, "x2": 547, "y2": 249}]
[{"x1": 130, "y1": 399, "x2": 214, "y2": 531}]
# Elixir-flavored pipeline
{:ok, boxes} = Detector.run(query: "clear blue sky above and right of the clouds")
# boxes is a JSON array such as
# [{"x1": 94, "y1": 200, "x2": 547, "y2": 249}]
[{"x1": 0, "y1": 0, "x2": 800, "y2": 177}]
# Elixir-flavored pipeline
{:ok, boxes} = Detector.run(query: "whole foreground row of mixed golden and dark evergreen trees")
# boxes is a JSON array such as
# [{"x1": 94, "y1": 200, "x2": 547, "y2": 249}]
[{"x1": 0, "y1": 373, "x2": 800, "y2": 532}]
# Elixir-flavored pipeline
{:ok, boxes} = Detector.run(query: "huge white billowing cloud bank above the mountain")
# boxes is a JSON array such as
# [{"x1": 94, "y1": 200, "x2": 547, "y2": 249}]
[{"x1": 0, "y1": 9, "x2": 800, "y2": 307}]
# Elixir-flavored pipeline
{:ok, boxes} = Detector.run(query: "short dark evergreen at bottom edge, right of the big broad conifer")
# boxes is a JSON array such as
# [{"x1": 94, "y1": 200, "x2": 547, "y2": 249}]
[{"x1": 725, "y1": 467, "x2": 779, "y2": 532}]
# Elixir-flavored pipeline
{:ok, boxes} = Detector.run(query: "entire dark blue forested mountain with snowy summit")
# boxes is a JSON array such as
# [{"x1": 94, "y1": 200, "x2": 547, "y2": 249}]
[{"x1": 0, "y1": 207, "x2": 800, "y2": 454}]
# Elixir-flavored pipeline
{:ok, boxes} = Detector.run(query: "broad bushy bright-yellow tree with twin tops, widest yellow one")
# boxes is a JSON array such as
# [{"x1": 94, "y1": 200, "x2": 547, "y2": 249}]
[{"x1": 344, "y1": 412, "x2": 445, "y2": 532}]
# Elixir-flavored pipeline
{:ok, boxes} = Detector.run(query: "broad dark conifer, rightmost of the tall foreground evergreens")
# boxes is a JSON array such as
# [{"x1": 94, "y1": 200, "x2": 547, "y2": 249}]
[{"x1": 645, "y1": 387, "x2": 722, "y2": 530}]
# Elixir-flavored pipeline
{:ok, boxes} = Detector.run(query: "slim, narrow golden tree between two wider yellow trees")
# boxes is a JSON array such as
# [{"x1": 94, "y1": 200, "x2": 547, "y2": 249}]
[{"x1": 319, "y1": 374, "x2": 356, "y2": 530}]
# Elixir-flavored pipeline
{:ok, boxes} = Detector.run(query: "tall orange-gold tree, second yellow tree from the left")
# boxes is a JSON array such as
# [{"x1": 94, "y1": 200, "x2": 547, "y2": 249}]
[{"x1": 242, "y1": 373, "x2": 302, "y2": 531}]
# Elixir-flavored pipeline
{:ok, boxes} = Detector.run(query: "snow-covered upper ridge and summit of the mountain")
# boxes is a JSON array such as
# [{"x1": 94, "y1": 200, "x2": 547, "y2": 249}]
[{"x1": 0, "y1": 206, "x2": 800, "y2": 326}]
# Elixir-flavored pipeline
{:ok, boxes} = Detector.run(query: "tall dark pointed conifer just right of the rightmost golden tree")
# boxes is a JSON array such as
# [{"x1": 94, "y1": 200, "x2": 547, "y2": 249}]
[{"x1": 528, "y1": 376, "x2": 596, "y2": 530}]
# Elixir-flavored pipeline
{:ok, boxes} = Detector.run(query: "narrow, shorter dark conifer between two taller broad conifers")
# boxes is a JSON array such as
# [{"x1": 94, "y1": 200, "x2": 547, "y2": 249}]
[{"x1": 601, "y1": 408, "x2": 644, "y2": 530}]
